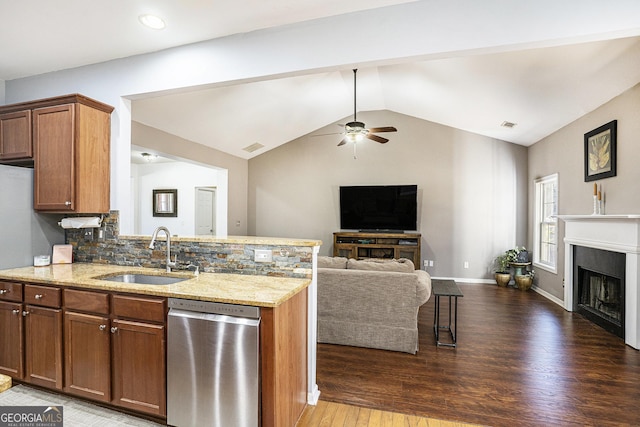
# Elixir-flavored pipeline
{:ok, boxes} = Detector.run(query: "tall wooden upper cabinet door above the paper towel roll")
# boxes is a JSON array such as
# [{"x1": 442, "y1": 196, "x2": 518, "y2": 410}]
[{"x1": 33, "y1": 104, "x2": 75, "y2": 211}]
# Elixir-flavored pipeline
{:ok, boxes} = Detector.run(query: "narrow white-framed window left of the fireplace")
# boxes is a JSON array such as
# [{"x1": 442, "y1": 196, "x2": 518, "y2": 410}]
[{"x1": 533, "y1": 174, "x2": 558, "y2": 273}]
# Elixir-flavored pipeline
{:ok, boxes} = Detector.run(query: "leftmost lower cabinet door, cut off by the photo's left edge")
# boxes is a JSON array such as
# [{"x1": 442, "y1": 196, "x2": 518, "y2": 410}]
[{"x1": 0, "y1": 301, "x2": 24, "y2": 379}]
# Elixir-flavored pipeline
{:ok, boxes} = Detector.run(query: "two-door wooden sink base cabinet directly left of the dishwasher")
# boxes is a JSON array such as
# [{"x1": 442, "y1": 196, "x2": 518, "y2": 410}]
[{"x1": 64, "y1": 289, "x2": 167, "y2": 417}]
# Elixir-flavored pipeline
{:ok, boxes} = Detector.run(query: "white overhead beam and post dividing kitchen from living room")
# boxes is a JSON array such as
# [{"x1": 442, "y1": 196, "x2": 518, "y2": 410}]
[{"x1": 5, "y1": 0, "x2": 640, "y2": 241}]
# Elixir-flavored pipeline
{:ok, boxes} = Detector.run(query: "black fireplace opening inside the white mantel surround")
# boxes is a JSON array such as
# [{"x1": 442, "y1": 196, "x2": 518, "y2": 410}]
[{"x1": 573, "y1": 246, "x2": 626, "y2": 338}]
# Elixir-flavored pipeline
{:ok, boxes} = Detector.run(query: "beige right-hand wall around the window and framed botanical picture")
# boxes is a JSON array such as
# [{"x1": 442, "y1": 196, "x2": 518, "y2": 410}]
[{"x1": 529, "y1": 85, "x2": 640, "y2": 300}]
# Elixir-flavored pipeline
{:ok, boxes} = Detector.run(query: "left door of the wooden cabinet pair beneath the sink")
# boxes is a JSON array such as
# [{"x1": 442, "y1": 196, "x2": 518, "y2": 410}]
[{"x1": 64, "y1": 311, "x2": 111, "y2": 402}]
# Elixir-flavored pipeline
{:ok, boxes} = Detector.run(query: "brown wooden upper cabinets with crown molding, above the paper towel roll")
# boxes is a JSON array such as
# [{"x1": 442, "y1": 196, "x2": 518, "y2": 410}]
[{"x1": 0, "y1": 94, "x2": 113, "y2": 213}]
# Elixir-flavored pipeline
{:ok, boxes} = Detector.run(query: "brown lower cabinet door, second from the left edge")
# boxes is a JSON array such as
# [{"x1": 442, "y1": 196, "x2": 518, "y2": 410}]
[{"x1": 23, "y1": 305, "x2": 62, "y2": 390}]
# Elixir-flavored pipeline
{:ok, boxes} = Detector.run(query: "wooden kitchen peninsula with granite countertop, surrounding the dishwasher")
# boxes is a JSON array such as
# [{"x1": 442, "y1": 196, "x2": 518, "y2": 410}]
[{"x1": 0, "y1": 256, "x2": 319, "y2": 426}]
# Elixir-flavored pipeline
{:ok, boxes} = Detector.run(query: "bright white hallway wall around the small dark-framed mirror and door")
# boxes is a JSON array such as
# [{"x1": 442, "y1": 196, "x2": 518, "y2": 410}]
[{"x1": 131, "y1": 162, "x2": 227, "y2": 236}]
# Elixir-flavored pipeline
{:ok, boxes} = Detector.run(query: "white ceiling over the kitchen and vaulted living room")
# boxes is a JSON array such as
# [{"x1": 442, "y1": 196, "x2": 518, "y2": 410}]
[{"x1": 0, "y1": 0, "x2": 640, "y2": 159}]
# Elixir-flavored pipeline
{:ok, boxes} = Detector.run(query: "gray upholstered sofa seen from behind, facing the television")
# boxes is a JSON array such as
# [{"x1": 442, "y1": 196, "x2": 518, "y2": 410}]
[{"x1": 318, "y1": 256, "x2": 431, "y2": 354}]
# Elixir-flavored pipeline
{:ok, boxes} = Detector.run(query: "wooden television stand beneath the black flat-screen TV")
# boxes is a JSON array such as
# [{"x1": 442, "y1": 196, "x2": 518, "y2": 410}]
[{"x1": 333, "y1": 231, "x2": 422, "y2": 269}]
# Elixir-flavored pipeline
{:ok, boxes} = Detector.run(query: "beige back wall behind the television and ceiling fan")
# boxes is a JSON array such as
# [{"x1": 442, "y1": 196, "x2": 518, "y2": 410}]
[{"x1": 249, "y1": 111, "x2": 527, "y2": 279}]
